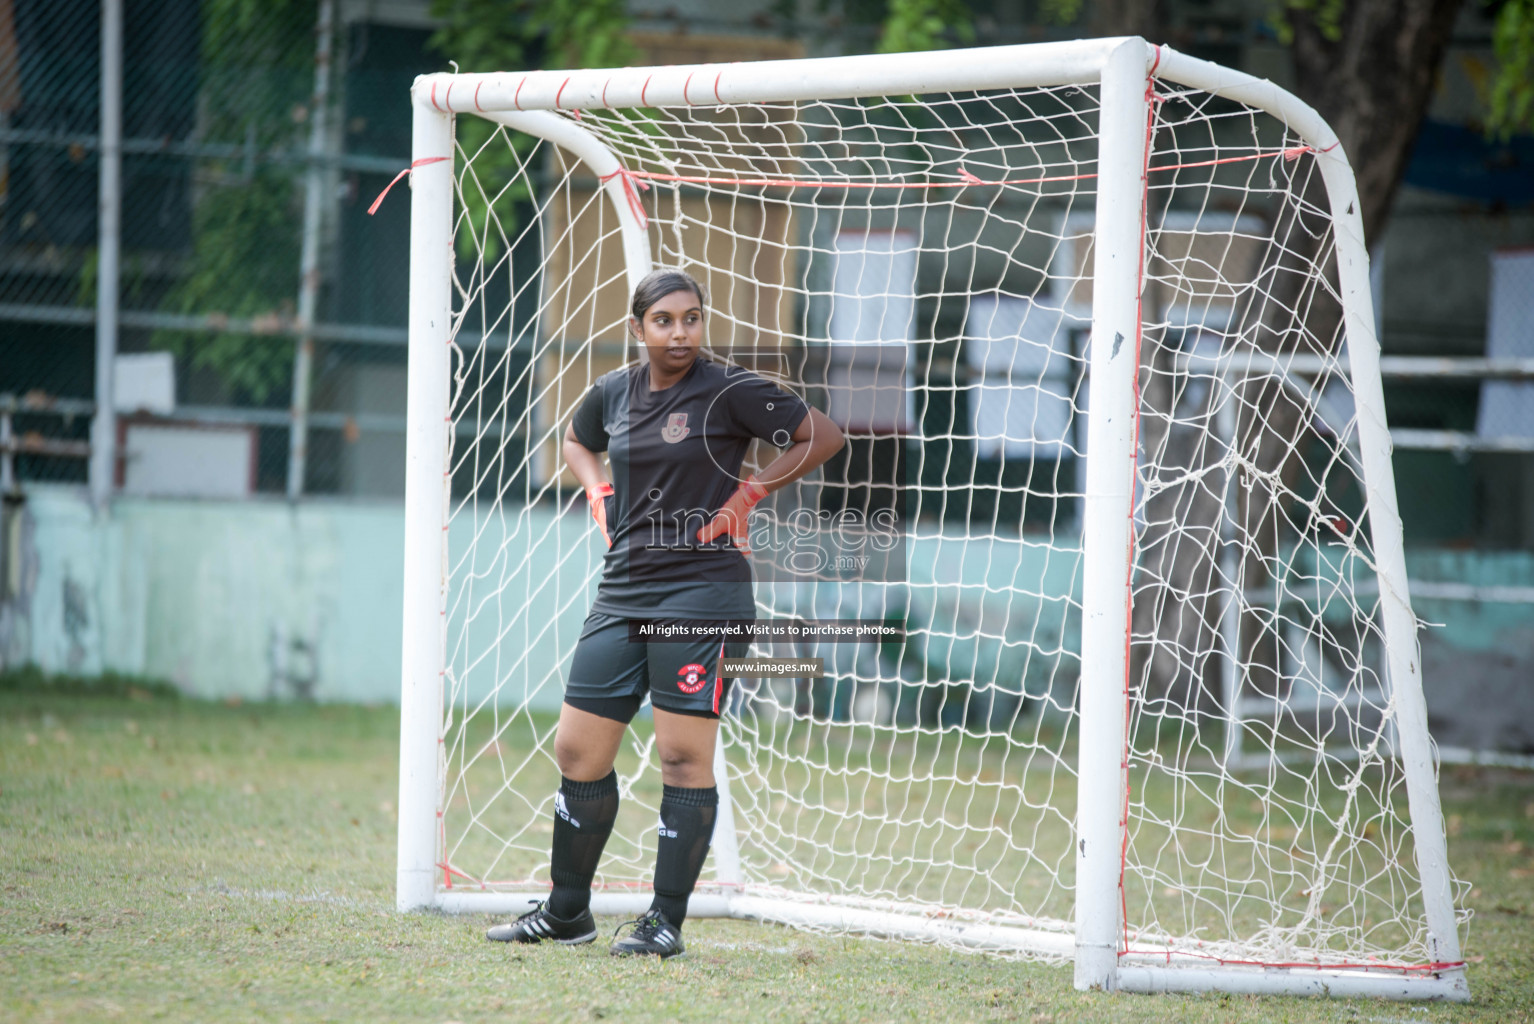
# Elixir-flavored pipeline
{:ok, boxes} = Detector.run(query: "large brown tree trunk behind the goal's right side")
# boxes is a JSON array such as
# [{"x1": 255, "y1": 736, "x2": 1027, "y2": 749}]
[{"x1": 1104, "y1": 0, "x2": 1491, "y2": 711}]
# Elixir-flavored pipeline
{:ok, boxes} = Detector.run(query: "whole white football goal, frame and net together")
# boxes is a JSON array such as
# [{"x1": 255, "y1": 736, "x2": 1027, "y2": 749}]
[{"x1": 397, "y1": 38, "x2": 1468, "y2": 999}]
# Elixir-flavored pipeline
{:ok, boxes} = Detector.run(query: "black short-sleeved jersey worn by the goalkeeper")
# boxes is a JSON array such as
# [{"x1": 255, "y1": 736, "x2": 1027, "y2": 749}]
[{"x1": 571, "y1": 356, "x2": 810, "y2": 618}]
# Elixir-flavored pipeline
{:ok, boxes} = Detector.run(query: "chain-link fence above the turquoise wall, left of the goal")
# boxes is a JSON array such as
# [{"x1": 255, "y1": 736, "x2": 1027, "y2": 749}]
[{"x1": 0, "y1": 0, "x2": 440, "y2": 497}]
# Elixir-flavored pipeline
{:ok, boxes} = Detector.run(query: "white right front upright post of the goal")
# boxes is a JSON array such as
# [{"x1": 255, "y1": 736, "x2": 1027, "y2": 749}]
[{"x1": 1075, "y1": 38, "x2": 1147, "y2": 989}]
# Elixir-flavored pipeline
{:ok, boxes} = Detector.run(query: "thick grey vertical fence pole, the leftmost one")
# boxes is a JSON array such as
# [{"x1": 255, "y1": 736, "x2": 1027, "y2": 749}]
[{"x1": 87, "y1": 0, "x2": 123, "y2": 509}]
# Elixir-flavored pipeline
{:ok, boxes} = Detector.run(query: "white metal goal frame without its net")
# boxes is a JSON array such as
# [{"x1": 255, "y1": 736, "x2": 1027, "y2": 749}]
[{"x1": 397, "y1": 38, "x2": 1470, "y2": 999}]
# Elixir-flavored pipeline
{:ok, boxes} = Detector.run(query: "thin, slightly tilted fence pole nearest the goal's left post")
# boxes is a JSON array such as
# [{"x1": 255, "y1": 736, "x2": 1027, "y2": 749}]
[{"x1": 287, "y1": 0, "x2": 336, "y2": 501}]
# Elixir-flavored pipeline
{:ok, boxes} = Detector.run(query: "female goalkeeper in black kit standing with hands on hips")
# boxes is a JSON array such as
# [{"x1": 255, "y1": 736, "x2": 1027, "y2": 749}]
[{"x1": 488, "y1": 270, "x2": 842, "y2": 958}]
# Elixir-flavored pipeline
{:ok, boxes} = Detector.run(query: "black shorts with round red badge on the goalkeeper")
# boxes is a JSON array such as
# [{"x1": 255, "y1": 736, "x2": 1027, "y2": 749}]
[{"x1": 565, "y1": 612, "x2": 750, "y2": 717}]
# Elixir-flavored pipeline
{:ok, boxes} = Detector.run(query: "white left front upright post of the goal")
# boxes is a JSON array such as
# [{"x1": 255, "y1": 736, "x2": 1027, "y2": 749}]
[{"x1": 394, "y1": 91, "x2": 453, "y2": 911}]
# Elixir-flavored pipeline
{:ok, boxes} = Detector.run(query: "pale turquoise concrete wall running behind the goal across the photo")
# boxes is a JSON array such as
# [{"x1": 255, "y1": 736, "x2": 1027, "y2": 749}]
[{"x1": 0, "y1": 487, "x2": 1534, "y2": 753}]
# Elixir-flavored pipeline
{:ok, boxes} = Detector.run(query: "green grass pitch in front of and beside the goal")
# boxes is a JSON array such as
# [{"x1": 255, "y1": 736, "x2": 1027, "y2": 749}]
[{"x1": 0, "y1": 682, "x2": 1534, "y2": 1024}]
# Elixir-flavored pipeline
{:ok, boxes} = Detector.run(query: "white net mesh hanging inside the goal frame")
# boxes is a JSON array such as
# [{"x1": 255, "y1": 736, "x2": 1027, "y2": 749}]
[{"x1": 440, "y1": 75, "x2": 1460, "y2": 966}]
